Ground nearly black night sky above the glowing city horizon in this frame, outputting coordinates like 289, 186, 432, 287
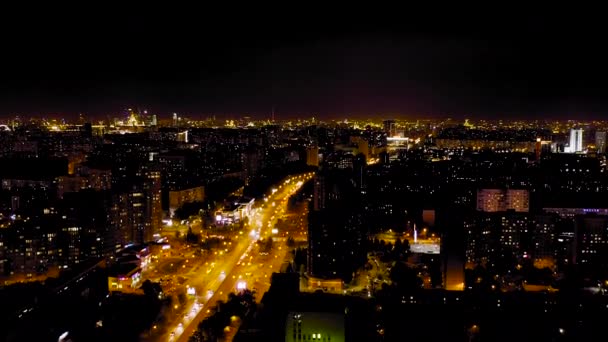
0, 4, 608, 118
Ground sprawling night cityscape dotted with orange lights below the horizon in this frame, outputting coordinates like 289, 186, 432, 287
0, 69, 608, 342
